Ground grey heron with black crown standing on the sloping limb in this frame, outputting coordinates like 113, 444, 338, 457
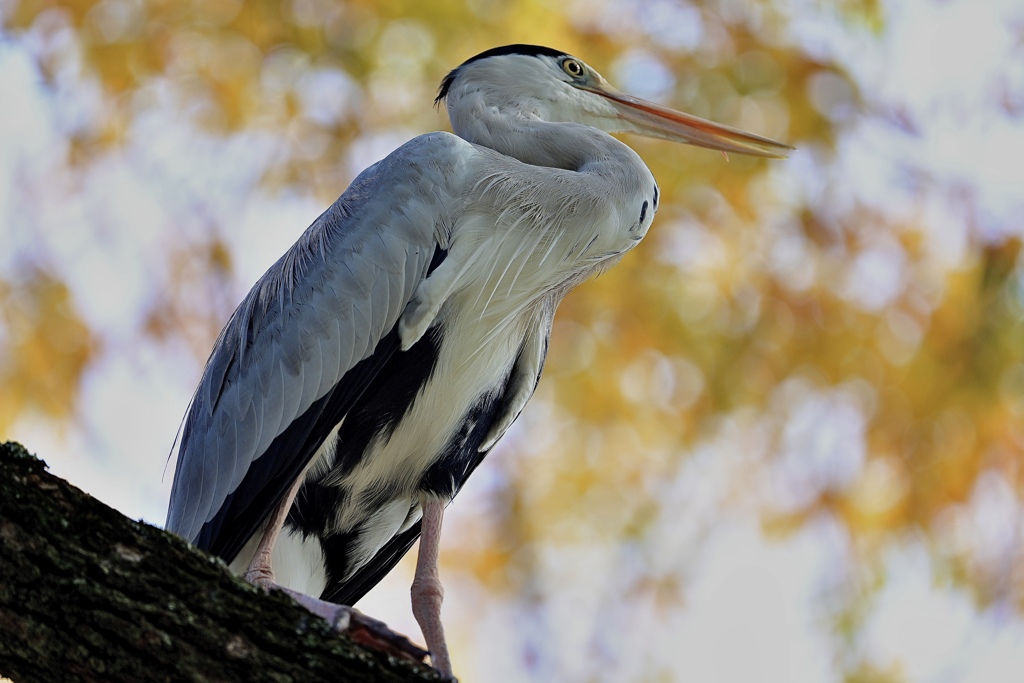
167, 45, 792, 676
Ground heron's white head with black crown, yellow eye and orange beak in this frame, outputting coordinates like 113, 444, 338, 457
435, 45, 793, 159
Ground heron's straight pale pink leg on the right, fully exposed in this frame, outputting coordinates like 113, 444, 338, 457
412, 499, 452, 678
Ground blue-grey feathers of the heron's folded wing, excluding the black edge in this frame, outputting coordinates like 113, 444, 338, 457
167, 133, 465, 541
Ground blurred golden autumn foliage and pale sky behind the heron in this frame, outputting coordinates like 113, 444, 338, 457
0, 0, 1024, 681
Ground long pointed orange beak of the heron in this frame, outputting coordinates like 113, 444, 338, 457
577, 80, 795, 159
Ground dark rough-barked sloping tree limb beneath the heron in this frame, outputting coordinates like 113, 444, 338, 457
0, 442, 438, 683
